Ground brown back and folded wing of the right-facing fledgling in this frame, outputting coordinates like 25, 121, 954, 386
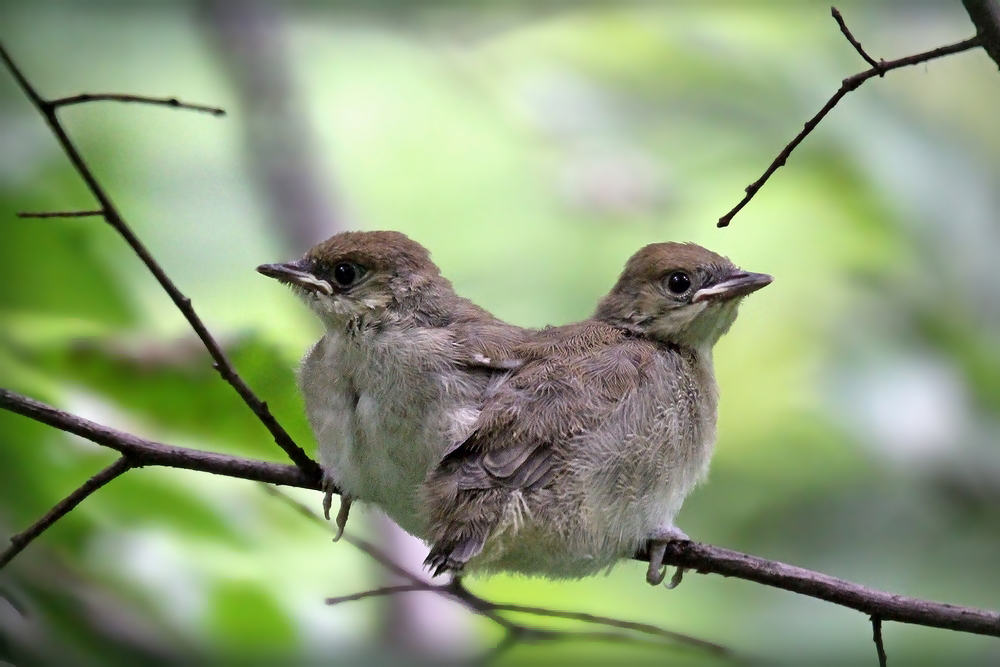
425, 322, 655, 572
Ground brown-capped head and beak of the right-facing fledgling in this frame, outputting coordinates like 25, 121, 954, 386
595, 243, 772, 349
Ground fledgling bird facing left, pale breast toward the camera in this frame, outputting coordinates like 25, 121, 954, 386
257, 231, 524, 537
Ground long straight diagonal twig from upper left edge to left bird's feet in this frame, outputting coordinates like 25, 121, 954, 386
0, 44, 322, 480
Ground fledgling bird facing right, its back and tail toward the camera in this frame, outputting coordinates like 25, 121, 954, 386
422, 243, 771, 584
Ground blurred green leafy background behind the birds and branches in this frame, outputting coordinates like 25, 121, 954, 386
0, 0, 1000, 665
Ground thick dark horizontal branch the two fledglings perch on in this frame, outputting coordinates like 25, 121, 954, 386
0, 389, 1000, 637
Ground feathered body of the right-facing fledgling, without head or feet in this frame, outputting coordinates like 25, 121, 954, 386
425, 322, 717, 577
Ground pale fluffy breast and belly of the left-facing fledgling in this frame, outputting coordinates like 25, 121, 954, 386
299, 328, 482, 537
